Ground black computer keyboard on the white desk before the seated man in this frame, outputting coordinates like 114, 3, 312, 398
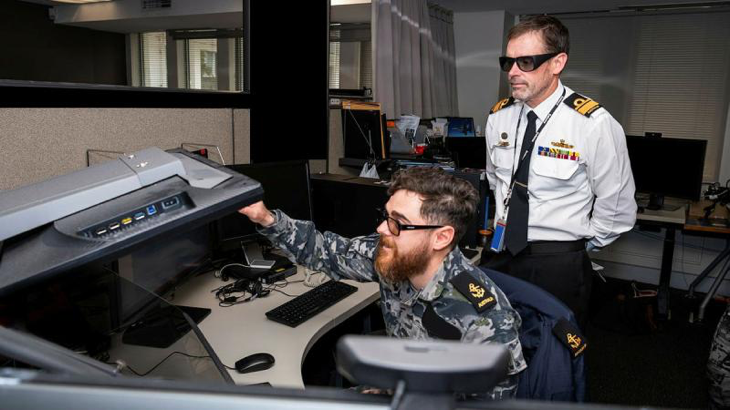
266, 280, 357, 327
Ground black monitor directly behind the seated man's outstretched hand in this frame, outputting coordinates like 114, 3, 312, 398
217, 160, 312, 249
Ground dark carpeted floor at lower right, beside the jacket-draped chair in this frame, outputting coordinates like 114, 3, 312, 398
585, 279, 725, 408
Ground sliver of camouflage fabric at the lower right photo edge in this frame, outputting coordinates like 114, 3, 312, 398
707, 305, 730, 409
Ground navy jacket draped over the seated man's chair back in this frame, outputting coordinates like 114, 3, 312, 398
482, 268, 587, 402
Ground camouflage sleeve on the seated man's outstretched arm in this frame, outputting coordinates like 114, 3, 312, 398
258, 210, 379, 282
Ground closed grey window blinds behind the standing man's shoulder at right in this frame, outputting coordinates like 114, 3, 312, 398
561, 11, 730, 182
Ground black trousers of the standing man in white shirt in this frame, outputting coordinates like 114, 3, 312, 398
481, 240, 593, 328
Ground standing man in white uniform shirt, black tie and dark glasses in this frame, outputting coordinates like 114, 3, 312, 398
483, 16, 636, 325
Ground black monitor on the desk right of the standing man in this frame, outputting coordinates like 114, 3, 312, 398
626, 135, 707, 209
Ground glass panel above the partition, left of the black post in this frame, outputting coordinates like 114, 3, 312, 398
0, 0, 248, 91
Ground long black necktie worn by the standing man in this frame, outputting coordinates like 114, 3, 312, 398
504, 111, 537, 255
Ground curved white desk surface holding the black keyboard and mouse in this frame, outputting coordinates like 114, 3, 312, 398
171, 268, 380, 389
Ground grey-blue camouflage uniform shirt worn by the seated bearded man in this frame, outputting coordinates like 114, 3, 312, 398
259, 210, 527, 399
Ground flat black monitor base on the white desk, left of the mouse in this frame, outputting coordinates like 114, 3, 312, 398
122, 305, 210, 349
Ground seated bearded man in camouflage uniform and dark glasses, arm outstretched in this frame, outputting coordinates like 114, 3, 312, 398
239, 168, 527, 399
